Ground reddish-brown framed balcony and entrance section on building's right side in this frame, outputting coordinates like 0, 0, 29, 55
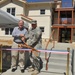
52, 0, 75, 43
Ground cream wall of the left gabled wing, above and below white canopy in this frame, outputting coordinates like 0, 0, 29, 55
0, 2, 23, 36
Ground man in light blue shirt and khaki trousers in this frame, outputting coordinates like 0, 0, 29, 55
11, 20, 27, 73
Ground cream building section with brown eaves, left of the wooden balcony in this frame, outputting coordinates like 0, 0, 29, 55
0, 0, 52, 38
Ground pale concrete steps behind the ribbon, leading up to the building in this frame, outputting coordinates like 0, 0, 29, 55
41, 43, 72, 75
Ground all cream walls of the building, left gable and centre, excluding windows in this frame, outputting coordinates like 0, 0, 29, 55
0, 0, 52, 39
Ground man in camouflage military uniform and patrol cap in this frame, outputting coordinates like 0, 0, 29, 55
25, 20, 42, 75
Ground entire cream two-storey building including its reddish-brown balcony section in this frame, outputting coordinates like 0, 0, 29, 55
0, 0, 75, 43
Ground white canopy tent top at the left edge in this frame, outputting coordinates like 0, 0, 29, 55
0, 9, 28, 27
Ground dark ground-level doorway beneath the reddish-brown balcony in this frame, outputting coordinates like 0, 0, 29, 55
59, 28, 71, 43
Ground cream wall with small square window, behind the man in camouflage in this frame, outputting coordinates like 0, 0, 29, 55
27, 4, 52, 38
